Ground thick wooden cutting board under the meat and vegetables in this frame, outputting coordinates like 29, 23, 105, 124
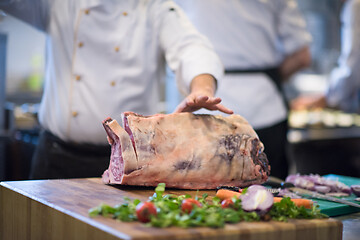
0, 178, 342, 240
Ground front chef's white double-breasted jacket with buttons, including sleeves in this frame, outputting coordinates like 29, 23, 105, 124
0, 0, 223, 144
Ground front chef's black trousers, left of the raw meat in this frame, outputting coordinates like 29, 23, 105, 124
30, 131, 111, 179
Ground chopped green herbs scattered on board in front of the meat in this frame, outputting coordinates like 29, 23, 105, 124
89, 183, 327, 228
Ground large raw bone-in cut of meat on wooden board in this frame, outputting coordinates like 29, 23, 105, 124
102, 112, 270, 189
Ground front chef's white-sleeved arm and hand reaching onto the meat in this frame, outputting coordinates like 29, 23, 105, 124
154, 1, 233, 114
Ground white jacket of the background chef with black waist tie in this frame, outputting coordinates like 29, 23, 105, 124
176, 0, 311, 128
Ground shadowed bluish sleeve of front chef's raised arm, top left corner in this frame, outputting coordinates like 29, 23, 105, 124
0, 0, 53, 31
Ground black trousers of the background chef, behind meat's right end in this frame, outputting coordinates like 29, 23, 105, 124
255, 121, 289, 179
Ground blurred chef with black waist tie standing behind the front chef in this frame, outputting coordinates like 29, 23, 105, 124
177, 0, 312, 178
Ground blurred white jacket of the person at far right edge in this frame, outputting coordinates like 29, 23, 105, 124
326, 0, 360, 112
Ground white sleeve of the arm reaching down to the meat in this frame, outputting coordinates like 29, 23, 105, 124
154, 1, 224, 95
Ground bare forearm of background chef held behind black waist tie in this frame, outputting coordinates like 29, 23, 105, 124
280, 46, 311, 81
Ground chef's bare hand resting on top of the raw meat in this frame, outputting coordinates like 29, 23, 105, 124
174, 74, 233, 114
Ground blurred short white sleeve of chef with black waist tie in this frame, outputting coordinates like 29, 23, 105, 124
275, 0, 312, 54
